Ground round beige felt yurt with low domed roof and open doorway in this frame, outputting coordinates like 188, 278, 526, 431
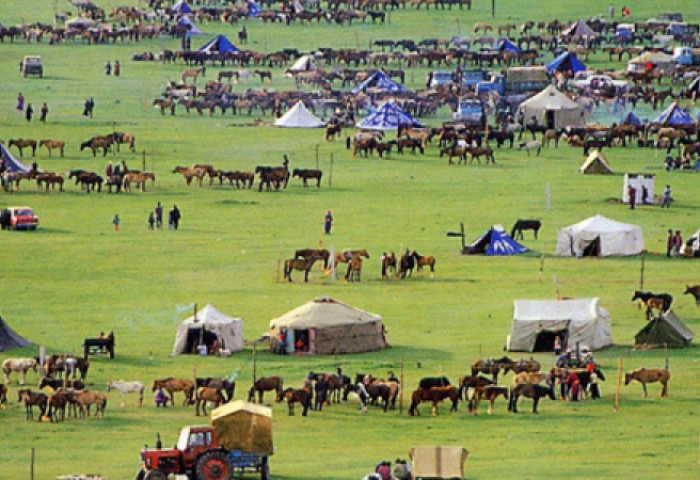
268, 297, 386, 355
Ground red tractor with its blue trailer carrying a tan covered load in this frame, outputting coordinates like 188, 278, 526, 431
136, 401, 272, 480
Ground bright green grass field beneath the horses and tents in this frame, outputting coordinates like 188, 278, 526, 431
0, 0, 700, 480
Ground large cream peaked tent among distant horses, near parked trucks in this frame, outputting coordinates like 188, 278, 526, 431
516, 85, 586, 129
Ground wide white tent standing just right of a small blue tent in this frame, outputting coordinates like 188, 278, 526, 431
556, 215, 644, 257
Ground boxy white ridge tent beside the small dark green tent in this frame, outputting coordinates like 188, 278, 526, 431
507, 298, 612, 352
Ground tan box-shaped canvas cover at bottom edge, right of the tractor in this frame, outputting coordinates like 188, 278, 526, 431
409, 445, 469, 480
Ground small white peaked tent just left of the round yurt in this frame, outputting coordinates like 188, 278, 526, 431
173, 303, 243, 353
